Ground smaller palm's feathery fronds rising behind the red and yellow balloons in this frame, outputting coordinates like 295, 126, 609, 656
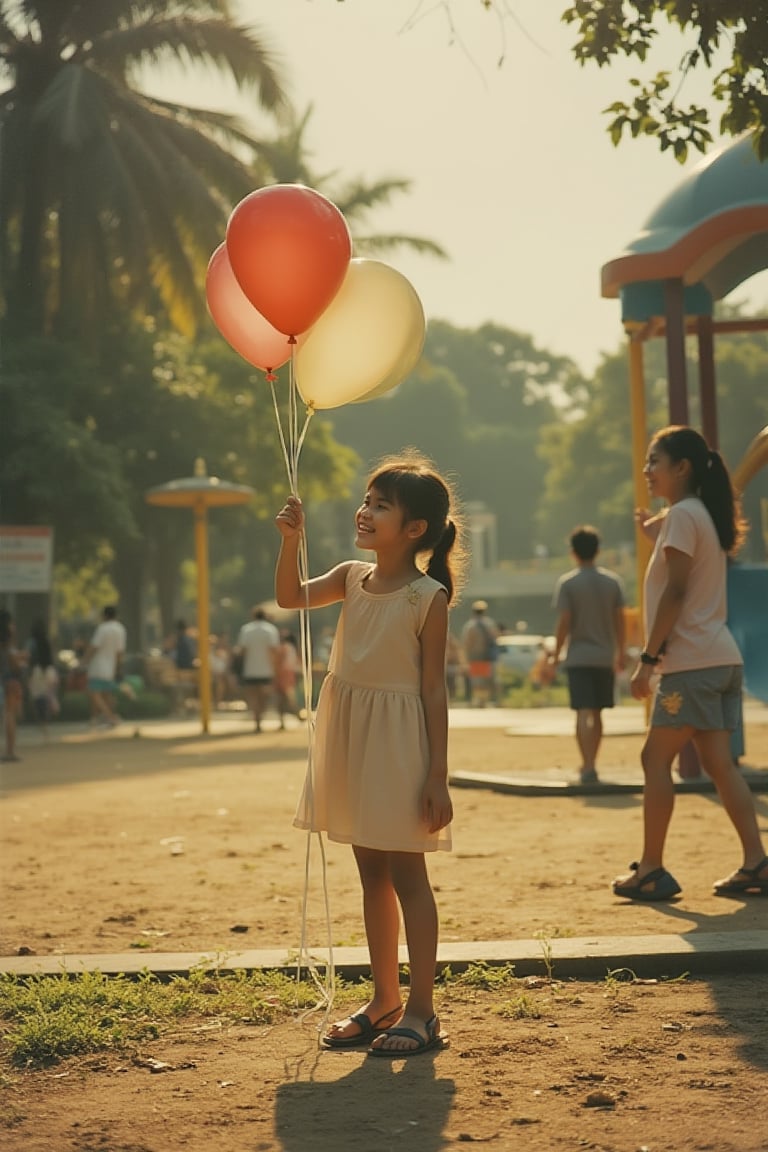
249, 105, 447, 259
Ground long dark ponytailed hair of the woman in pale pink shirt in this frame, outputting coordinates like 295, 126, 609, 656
653, 424, 747, 555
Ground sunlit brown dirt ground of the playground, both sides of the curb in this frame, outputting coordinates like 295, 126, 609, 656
0, 725, 768, 1152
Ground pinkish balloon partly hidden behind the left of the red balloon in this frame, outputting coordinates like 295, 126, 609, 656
205, 244, 291, 372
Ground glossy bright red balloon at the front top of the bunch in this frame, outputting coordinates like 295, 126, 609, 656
227, 184, 352, 336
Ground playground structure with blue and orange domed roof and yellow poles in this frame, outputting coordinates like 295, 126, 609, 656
601, 134, 768, 775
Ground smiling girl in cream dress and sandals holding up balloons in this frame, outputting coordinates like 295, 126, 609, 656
275, 454, 459, 1056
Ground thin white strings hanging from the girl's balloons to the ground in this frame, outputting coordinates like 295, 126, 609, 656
269, 352, 336, 1032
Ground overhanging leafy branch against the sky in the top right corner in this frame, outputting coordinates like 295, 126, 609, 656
562, 0, 768, 162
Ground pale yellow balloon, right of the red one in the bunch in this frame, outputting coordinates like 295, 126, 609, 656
296, 257, 426, 409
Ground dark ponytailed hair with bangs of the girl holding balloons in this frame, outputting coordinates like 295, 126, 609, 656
367, 449, 465, 601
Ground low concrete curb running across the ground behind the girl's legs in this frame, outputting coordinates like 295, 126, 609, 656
0, 931, 768, 980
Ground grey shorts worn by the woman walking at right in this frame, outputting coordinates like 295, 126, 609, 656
651, 664, 743, 732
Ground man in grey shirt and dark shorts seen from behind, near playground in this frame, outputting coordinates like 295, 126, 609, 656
550, 524, 625, 785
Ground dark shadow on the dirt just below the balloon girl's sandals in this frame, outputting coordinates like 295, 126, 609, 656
275, 1052, 456, 1152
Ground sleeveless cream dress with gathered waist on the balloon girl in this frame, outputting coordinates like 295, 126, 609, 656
294, 561, 450, 852
